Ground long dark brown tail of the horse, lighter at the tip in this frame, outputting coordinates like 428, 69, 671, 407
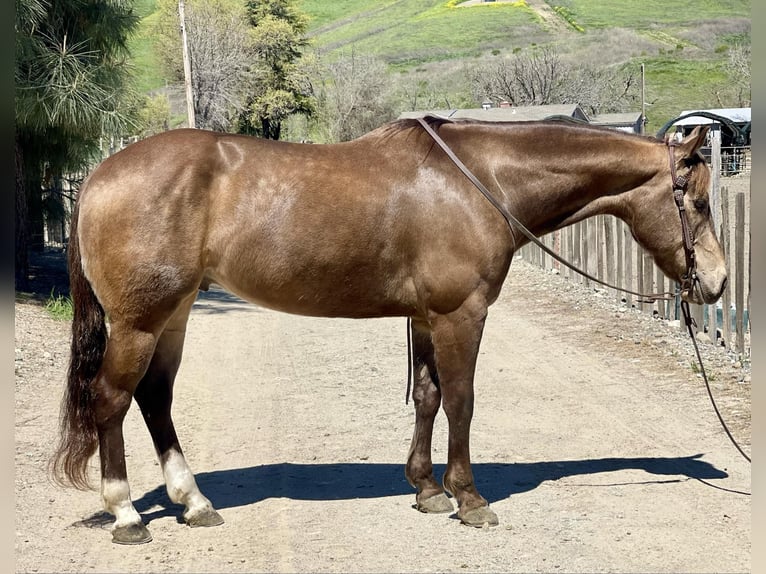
52, 196, 107, 490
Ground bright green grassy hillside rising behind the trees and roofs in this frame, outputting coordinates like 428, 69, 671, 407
132, 0, 751, 131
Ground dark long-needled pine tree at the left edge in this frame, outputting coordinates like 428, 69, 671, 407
14, 0, 138, 288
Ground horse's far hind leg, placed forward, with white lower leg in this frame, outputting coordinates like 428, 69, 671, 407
135, 293, 223, 526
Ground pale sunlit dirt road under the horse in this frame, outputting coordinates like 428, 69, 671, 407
15, 262, 751, 572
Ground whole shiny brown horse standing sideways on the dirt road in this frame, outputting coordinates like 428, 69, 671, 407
51, 116, 726, 544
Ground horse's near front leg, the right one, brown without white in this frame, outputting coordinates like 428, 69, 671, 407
432, 297, 498, 527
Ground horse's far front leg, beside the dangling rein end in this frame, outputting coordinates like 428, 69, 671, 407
405, 322, 453, 512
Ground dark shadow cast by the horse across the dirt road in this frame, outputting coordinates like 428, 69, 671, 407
114, 454, 729, 532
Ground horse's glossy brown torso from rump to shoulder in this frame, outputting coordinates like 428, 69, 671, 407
75, 128, 509, 324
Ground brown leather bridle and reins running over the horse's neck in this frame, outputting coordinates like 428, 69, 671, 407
416, 118, 751, 468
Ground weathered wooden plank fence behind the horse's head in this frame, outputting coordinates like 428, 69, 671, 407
521, 184, 750, 359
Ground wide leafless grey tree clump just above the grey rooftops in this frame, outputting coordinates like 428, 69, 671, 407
472, 47, 640, 114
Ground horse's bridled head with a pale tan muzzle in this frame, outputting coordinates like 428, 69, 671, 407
632, 127, 726, 304
